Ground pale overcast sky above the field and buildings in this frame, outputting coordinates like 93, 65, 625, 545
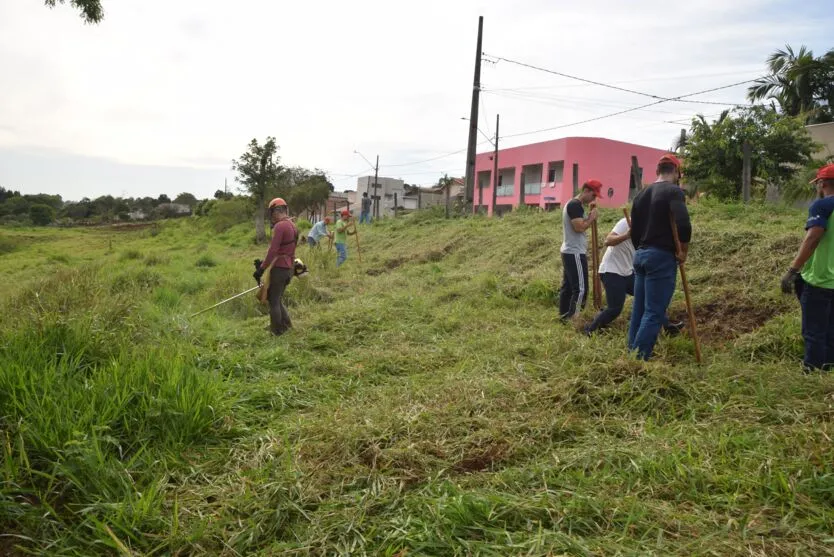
0, 0, 834, 199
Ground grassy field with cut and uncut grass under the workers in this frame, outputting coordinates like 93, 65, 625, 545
0, 201, 834, 556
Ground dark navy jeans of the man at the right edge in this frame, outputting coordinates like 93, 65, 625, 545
799, 282, 834, 370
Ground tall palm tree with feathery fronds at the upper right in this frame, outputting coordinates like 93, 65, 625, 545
747, 45, 834, 124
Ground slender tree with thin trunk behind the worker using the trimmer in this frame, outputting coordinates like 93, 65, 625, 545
232, 137, 284, 243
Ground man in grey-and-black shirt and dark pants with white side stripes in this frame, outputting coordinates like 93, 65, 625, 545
559, 180, 602, 322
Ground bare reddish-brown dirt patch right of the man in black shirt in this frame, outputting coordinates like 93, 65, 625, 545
669, 301, 785, 344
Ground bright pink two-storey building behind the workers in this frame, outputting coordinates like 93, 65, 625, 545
473, 137, 667, 215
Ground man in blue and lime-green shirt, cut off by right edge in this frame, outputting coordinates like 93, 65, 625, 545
781, 164, 834, 371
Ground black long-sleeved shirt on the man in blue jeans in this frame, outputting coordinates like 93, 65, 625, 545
631, 182, 692, 253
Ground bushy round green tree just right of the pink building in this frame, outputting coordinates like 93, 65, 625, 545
683, 106, 816, 199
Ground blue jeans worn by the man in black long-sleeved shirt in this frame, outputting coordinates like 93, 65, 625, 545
628, 247, 678, 360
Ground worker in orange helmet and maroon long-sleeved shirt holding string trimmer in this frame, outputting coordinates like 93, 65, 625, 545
255, 197, 298, 336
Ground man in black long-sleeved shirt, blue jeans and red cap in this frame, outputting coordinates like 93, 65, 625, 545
628, 154, 692, 360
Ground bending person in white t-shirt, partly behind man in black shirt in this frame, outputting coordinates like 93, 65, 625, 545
585, 219, 683, 335
